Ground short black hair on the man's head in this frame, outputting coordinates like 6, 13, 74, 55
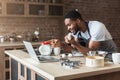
64, 10, 83, 20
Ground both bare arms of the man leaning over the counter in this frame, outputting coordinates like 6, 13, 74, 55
51, 39, 100, 55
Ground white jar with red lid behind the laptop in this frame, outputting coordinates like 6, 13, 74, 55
39, 41, 52, 56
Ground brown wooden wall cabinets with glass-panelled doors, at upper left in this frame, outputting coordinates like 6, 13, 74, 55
0, 0, 64, 17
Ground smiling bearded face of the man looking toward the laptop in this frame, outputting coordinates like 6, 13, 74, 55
64, 18, 80, 34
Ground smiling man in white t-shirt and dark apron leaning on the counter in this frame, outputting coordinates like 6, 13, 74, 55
52, 10, 117, 55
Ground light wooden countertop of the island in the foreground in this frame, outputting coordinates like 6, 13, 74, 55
5, 50, 120, 80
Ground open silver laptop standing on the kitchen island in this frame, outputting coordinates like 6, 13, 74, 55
23, 41, 59, 62
